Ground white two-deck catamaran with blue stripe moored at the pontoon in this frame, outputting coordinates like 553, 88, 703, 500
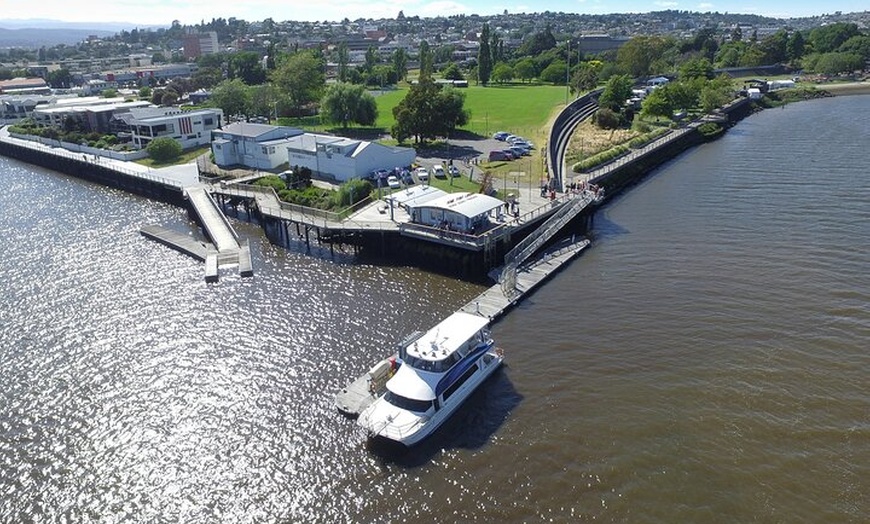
357, 312, 503, 446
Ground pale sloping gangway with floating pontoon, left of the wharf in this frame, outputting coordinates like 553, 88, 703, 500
139, 186, 254, 282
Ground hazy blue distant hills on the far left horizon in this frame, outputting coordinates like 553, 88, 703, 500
0, 19, 166, 49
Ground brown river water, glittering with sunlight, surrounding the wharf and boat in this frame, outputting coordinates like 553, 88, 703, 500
0, 96, 870, 523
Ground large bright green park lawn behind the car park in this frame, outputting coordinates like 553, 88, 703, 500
375, 84, 565, 137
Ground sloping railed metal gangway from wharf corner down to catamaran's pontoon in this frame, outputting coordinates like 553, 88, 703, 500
499, 190, 598, 297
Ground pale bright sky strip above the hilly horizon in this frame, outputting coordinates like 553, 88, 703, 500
0, 0, 868, 26
